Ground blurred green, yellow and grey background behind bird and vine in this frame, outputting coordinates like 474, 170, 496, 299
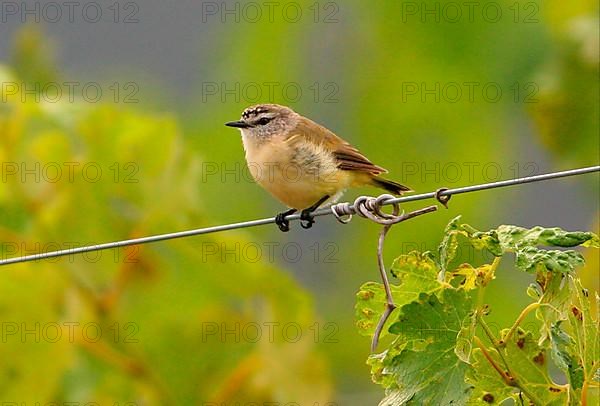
0, 0, 600, 405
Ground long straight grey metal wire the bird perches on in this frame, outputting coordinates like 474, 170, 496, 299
0, 165, 600, 266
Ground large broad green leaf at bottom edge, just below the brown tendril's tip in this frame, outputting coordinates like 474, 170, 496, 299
381, 289, 471, 405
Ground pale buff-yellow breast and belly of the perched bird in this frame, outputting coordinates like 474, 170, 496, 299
243, 137, 351, 210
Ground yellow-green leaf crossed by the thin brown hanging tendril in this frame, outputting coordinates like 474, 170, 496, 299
355, 251, 442, 337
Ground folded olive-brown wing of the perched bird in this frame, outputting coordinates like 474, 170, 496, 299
286, 118, 387, 175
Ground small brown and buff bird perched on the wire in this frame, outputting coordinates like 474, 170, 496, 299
225, 104, 411, 232
